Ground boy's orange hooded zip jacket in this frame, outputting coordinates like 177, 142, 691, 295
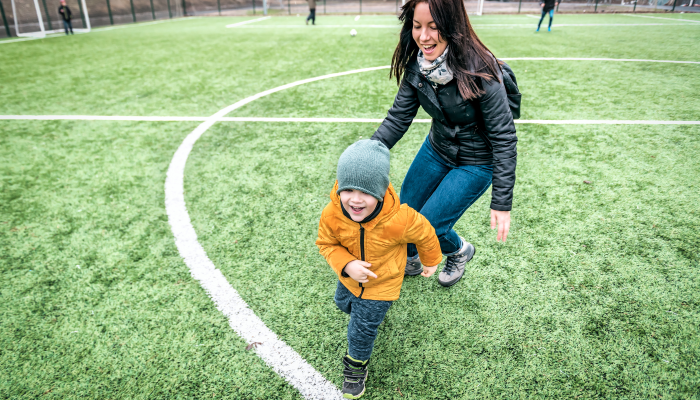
316, 181, 442, 301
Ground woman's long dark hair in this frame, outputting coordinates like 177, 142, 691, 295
389, 0, 498, 100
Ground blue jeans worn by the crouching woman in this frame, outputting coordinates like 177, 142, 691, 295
400, 138, 493, 257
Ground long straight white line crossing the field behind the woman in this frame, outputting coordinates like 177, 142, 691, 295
0, 115, 700, 125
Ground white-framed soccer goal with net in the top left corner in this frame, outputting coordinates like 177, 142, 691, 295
11, 0, 90, 37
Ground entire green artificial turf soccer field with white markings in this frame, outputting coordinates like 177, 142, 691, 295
0, 14, 700, 399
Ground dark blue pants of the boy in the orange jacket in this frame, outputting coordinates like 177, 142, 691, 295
335, 282, 393, 361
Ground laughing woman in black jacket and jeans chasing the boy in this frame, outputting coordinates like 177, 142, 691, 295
372, 0, 518, 287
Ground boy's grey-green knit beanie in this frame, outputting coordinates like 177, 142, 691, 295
337, 139, 389, 201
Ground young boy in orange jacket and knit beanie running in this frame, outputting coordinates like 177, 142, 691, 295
316, 139, 442, 399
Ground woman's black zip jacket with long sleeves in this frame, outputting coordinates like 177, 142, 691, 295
372, 60, 518, 211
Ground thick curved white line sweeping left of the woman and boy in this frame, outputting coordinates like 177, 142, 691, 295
165, 67, 396, 400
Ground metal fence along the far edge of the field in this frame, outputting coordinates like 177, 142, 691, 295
0, 0, 700, 37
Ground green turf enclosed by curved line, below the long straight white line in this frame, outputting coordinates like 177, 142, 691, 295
186, 123, 700, 399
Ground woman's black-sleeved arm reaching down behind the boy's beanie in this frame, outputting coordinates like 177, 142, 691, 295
371, 79, 420, 149
